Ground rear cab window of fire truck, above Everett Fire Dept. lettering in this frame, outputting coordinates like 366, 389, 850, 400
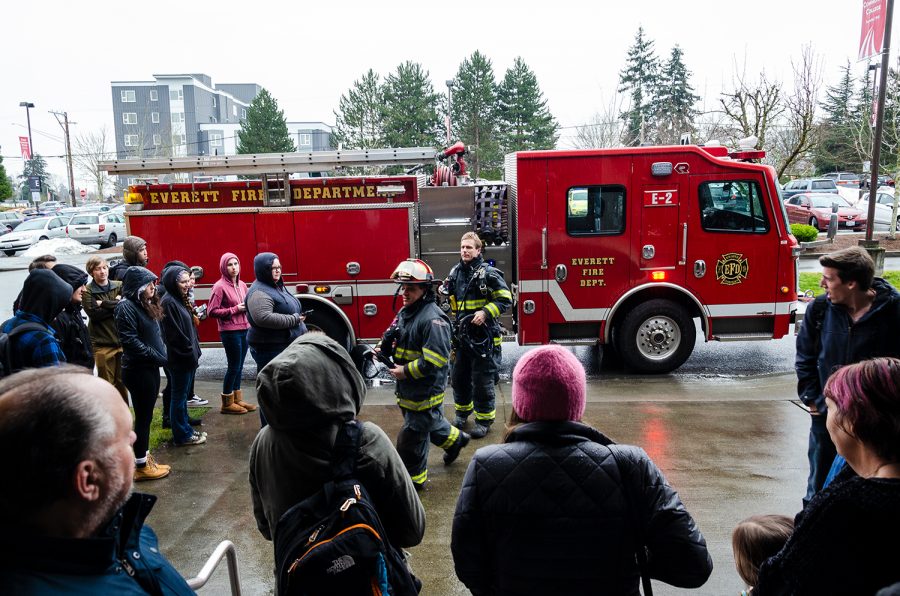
566, 186, 625, 236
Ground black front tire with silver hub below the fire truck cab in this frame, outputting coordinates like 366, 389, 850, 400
616, 299, 697, 374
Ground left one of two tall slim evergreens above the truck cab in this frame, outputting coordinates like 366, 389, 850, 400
619, 27, 659, 146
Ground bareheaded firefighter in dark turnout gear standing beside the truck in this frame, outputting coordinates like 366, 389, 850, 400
442, 232, 512, 439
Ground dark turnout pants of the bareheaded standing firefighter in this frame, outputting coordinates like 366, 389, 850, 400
450, 346, 500, 424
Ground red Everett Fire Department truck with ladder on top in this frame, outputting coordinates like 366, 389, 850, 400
104, 144, 799, 373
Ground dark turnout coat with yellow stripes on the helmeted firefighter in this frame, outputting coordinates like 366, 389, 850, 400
394, 294, 450, 411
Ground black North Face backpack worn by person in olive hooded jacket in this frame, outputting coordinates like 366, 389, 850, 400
274, 420, 421, 596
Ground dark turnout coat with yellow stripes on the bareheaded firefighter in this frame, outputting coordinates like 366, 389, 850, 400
446, 256, 512, 344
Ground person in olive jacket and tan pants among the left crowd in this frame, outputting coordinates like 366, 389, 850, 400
81, 256, 128, 404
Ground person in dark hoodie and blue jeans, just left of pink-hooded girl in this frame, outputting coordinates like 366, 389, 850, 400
161, 265, 206, 446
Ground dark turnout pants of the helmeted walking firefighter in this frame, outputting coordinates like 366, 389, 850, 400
397, 405, 460, 485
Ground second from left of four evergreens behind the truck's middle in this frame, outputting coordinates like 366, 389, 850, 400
382, 61, 441, 147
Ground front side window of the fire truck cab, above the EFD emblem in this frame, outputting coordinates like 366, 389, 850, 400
699, 180, 769, 234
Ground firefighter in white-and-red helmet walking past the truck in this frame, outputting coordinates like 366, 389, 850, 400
378, 259, 469, 490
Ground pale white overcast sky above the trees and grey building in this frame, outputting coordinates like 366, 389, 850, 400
0, 0, 900, 187
